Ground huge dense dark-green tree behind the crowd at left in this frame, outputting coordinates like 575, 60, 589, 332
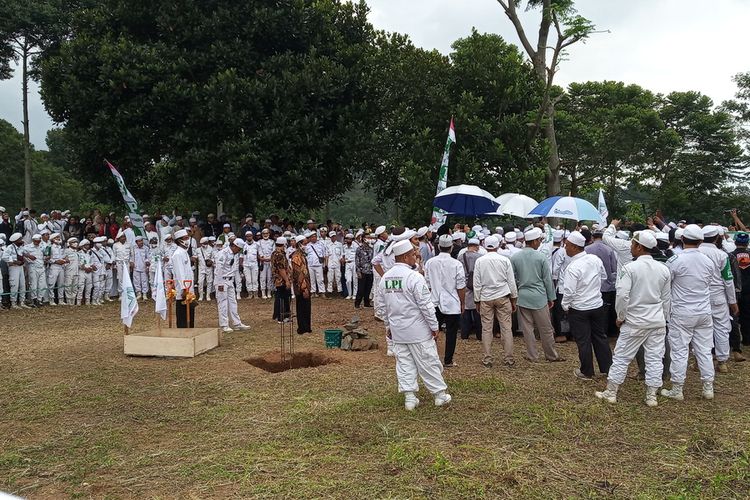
37, 0, 373, 213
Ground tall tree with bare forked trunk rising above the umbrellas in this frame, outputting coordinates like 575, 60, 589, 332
497, 0, 594, 196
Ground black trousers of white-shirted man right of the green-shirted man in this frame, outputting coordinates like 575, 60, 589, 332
568, 306, 612, 377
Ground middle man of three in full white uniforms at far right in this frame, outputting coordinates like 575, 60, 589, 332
660, 224, 716, 401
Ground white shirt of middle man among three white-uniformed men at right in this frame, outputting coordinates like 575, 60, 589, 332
667, 248, 714, 316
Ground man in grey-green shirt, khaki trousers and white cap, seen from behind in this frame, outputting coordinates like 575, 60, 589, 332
510, 227, 564, 362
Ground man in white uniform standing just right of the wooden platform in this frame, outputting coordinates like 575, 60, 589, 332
215, 238, 250, 333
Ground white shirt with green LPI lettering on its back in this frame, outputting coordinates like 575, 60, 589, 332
377, 263, 439, 344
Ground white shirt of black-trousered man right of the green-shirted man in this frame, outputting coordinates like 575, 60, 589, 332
561, 252, 607, 311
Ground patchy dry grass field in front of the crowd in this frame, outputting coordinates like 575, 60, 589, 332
0, 299, 750, 498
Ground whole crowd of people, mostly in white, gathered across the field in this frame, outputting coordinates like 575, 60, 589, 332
0, 207, 750, 410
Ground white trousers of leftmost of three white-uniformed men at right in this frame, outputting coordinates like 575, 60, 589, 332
607, 324, 667, 387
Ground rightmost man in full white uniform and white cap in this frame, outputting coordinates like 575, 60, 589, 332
698, 226, 740, 373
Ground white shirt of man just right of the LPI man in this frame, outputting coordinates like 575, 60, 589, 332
424, 253, 466, 314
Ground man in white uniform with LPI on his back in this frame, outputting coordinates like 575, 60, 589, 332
378, 239, 452, 410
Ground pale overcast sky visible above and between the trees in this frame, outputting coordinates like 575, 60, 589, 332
0, 0, 750, 149
